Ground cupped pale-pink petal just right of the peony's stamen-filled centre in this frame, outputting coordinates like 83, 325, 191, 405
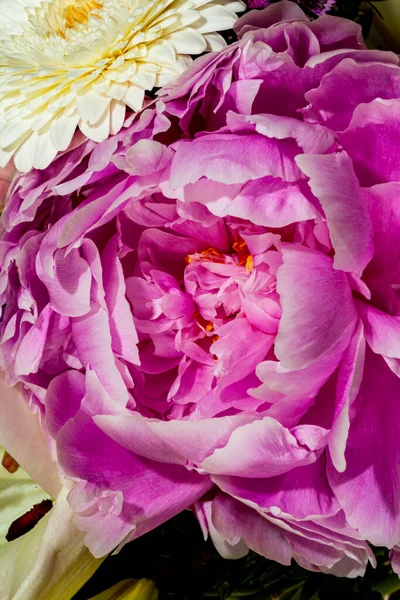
275, 246, 357, 369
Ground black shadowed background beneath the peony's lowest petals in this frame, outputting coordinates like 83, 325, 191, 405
73, 511, 400, 600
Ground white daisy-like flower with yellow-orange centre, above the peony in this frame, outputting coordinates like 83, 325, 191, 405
0, 0, 244, 172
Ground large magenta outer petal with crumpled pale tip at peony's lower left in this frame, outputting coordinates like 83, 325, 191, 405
56, 371, 211, 556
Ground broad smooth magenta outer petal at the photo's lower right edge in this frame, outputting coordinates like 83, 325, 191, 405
328, 352, 400, 548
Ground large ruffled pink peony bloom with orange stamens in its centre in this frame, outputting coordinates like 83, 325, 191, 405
0, 2, 400, 577
